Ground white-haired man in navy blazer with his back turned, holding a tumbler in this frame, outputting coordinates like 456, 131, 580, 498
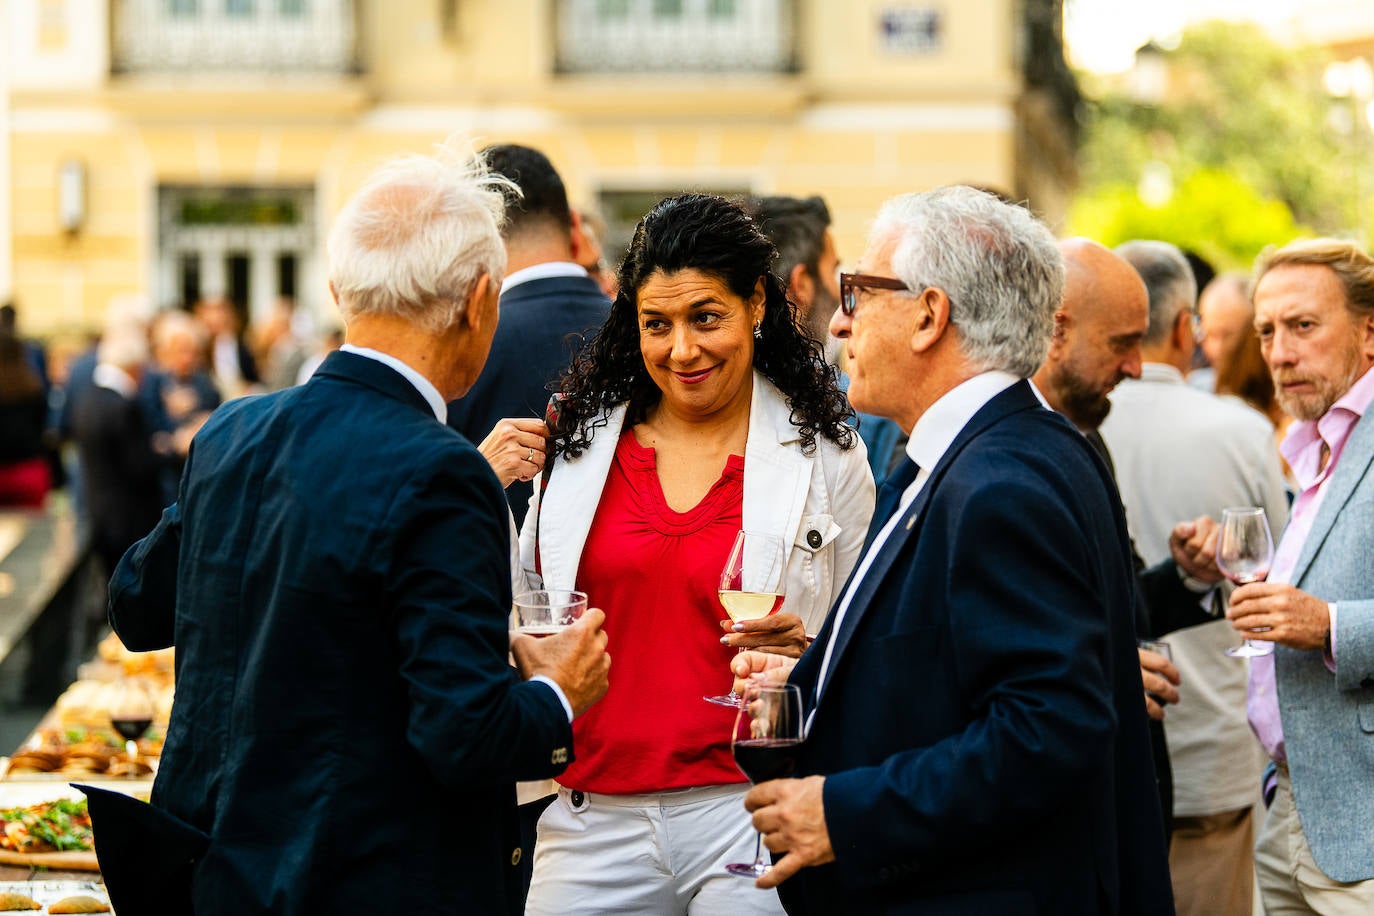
92, 146, 609, 916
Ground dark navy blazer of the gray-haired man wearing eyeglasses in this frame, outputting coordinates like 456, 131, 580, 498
780, 383, 1173, 916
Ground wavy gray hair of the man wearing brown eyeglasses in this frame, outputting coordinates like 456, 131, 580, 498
871, 185, 1063, 379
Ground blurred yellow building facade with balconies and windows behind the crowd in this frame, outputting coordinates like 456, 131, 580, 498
0, 0, 1076, 334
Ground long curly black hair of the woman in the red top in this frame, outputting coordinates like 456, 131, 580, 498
554, 194, 855, 457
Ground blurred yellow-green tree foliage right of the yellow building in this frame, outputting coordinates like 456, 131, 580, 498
1069, 22, 1357, 268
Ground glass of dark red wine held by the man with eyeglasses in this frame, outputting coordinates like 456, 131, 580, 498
725, 684, 802, 878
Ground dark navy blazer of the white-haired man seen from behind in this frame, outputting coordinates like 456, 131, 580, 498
107, 353, 572, 916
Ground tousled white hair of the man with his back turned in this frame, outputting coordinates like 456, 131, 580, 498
328, 144, 513, 334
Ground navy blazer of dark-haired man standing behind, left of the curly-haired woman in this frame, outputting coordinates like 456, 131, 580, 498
448, 276, 610, 530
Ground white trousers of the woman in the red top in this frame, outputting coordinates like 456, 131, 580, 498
525, 784, 783, 916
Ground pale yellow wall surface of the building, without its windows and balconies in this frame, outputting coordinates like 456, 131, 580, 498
2, 0, 1033, 335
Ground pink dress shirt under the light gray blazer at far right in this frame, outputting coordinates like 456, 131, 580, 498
1245, 369, 1374, 764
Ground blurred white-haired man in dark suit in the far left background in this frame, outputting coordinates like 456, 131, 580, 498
71, 324, 165, 573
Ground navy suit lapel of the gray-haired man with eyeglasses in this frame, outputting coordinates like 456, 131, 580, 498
818, 382, 1040, 703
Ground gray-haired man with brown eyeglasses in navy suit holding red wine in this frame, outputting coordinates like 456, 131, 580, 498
732, 187, 1172, 916
